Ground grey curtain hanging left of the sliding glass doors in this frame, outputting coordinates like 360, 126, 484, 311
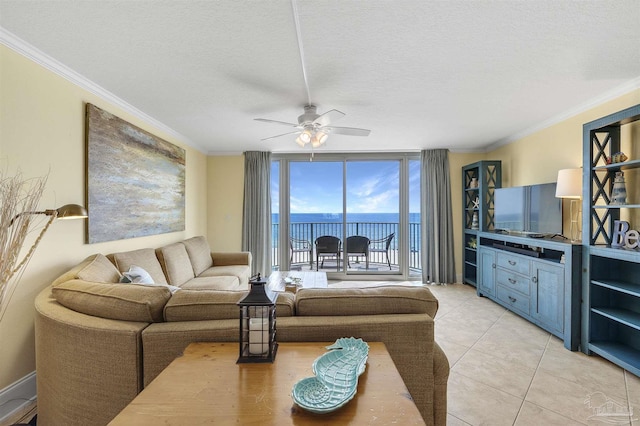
242, 151, 271, 278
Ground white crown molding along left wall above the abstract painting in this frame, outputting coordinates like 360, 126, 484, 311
0, 26, 205, 154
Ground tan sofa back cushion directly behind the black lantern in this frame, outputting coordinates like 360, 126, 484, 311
164, 290, 295, 322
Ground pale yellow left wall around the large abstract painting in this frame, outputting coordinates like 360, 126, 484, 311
0, 45, 207, 390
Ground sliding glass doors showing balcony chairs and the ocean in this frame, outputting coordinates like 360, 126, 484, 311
272, 154, 419, 279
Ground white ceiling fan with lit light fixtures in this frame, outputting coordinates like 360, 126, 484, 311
254, 104, 371, 148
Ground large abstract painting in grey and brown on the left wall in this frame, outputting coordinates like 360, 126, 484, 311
86, 104, 186, 244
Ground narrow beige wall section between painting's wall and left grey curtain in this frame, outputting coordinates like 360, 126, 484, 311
207, 155, 244, 251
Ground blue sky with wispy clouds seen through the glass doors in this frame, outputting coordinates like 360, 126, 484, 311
271, 160, 420, 213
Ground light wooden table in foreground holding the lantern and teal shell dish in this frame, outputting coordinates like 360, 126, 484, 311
109, 342, 425, 426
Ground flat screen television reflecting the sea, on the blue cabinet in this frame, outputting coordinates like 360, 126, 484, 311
494, 182, 562, 236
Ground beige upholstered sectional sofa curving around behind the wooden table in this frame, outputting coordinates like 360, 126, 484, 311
35, 237, 449, 426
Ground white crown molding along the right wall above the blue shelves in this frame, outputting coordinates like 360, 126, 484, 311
485, 77, 640, 152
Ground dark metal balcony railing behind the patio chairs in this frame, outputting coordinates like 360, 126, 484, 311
271, 222, 422, 272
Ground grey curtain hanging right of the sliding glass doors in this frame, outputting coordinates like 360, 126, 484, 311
420, 149, 456, 284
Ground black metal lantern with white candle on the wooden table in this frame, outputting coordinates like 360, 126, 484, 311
238, 274, 278, 363
